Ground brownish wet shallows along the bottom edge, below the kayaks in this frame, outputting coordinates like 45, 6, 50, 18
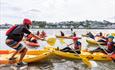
0, 59, 115, 70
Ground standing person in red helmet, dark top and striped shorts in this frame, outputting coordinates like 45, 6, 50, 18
6, 18, 40, 66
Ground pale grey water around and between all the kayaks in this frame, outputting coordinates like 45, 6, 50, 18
0, 29, 115, 70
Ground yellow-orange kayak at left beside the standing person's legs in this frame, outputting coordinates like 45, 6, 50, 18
0, 49, 52, 64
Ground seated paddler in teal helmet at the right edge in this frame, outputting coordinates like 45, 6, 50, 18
91, 36, 115, 54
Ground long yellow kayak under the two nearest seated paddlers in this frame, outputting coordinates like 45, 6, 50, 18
54, 50, 115, 61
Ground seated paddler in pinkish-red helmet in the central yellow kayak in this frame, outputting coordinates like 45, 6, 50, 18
60, 37, 81, 54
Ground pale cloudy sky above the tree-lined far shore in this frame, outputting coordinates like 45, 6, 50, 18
0, 0, 115, 24
